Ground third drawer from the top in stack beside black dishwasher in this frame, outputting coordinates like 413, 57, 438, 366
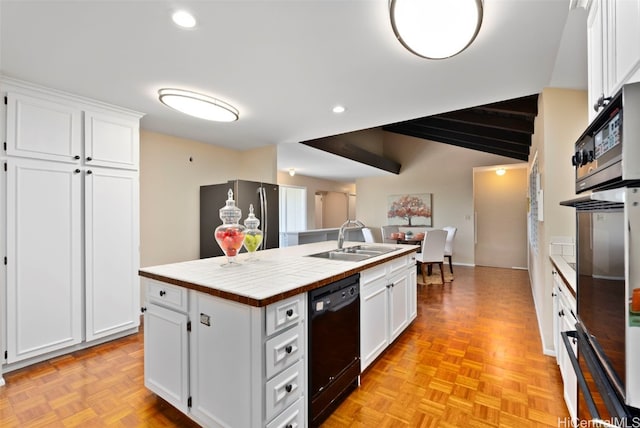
265, 360, 304, 420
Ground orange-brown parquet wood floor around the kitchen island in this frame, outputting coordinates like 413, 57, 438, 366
0, 267, 568, 428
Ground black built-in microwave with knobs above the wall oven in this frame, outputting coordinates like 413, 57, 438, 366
571, 82, 640, 193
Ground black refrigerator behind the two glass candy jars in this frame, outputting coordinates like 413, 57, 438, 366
200, 180, 280, 259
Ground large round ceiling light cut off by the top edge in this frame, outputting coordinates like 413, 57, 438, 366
389, 0, 482, 59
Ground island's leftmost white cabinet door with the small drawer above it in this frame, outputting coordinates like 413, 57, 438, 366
144, 280, 190, 413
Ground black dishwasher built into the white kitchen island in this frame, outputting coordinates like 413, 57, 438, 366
308, 274, 360, 427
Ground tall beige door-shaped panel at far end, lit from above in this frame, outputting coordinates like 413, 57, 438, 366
473, 165, 527, 268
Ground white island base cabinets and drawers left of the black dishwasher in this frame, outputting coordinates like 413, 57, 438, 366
143, 278, 306, 427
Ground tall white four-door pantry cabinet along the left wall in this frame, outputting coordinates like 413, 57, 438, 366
0, 77, 141, 369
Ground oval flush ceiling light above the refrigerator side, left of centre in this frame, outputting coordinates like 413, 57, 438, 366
158, 88, 240, 122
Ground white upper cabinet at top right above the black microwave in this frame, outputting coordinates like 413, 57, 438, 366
587, 0, 640, 121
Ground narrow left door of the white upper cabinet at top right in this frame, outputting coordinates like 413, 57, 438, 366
587, 0, 607, 121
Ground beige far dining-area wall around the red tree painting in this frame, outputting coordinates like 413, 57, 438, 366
356, 132, 518, 265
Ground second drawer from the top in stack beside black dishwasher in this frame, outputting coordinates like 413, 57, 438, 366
265, 324, 305, 379
